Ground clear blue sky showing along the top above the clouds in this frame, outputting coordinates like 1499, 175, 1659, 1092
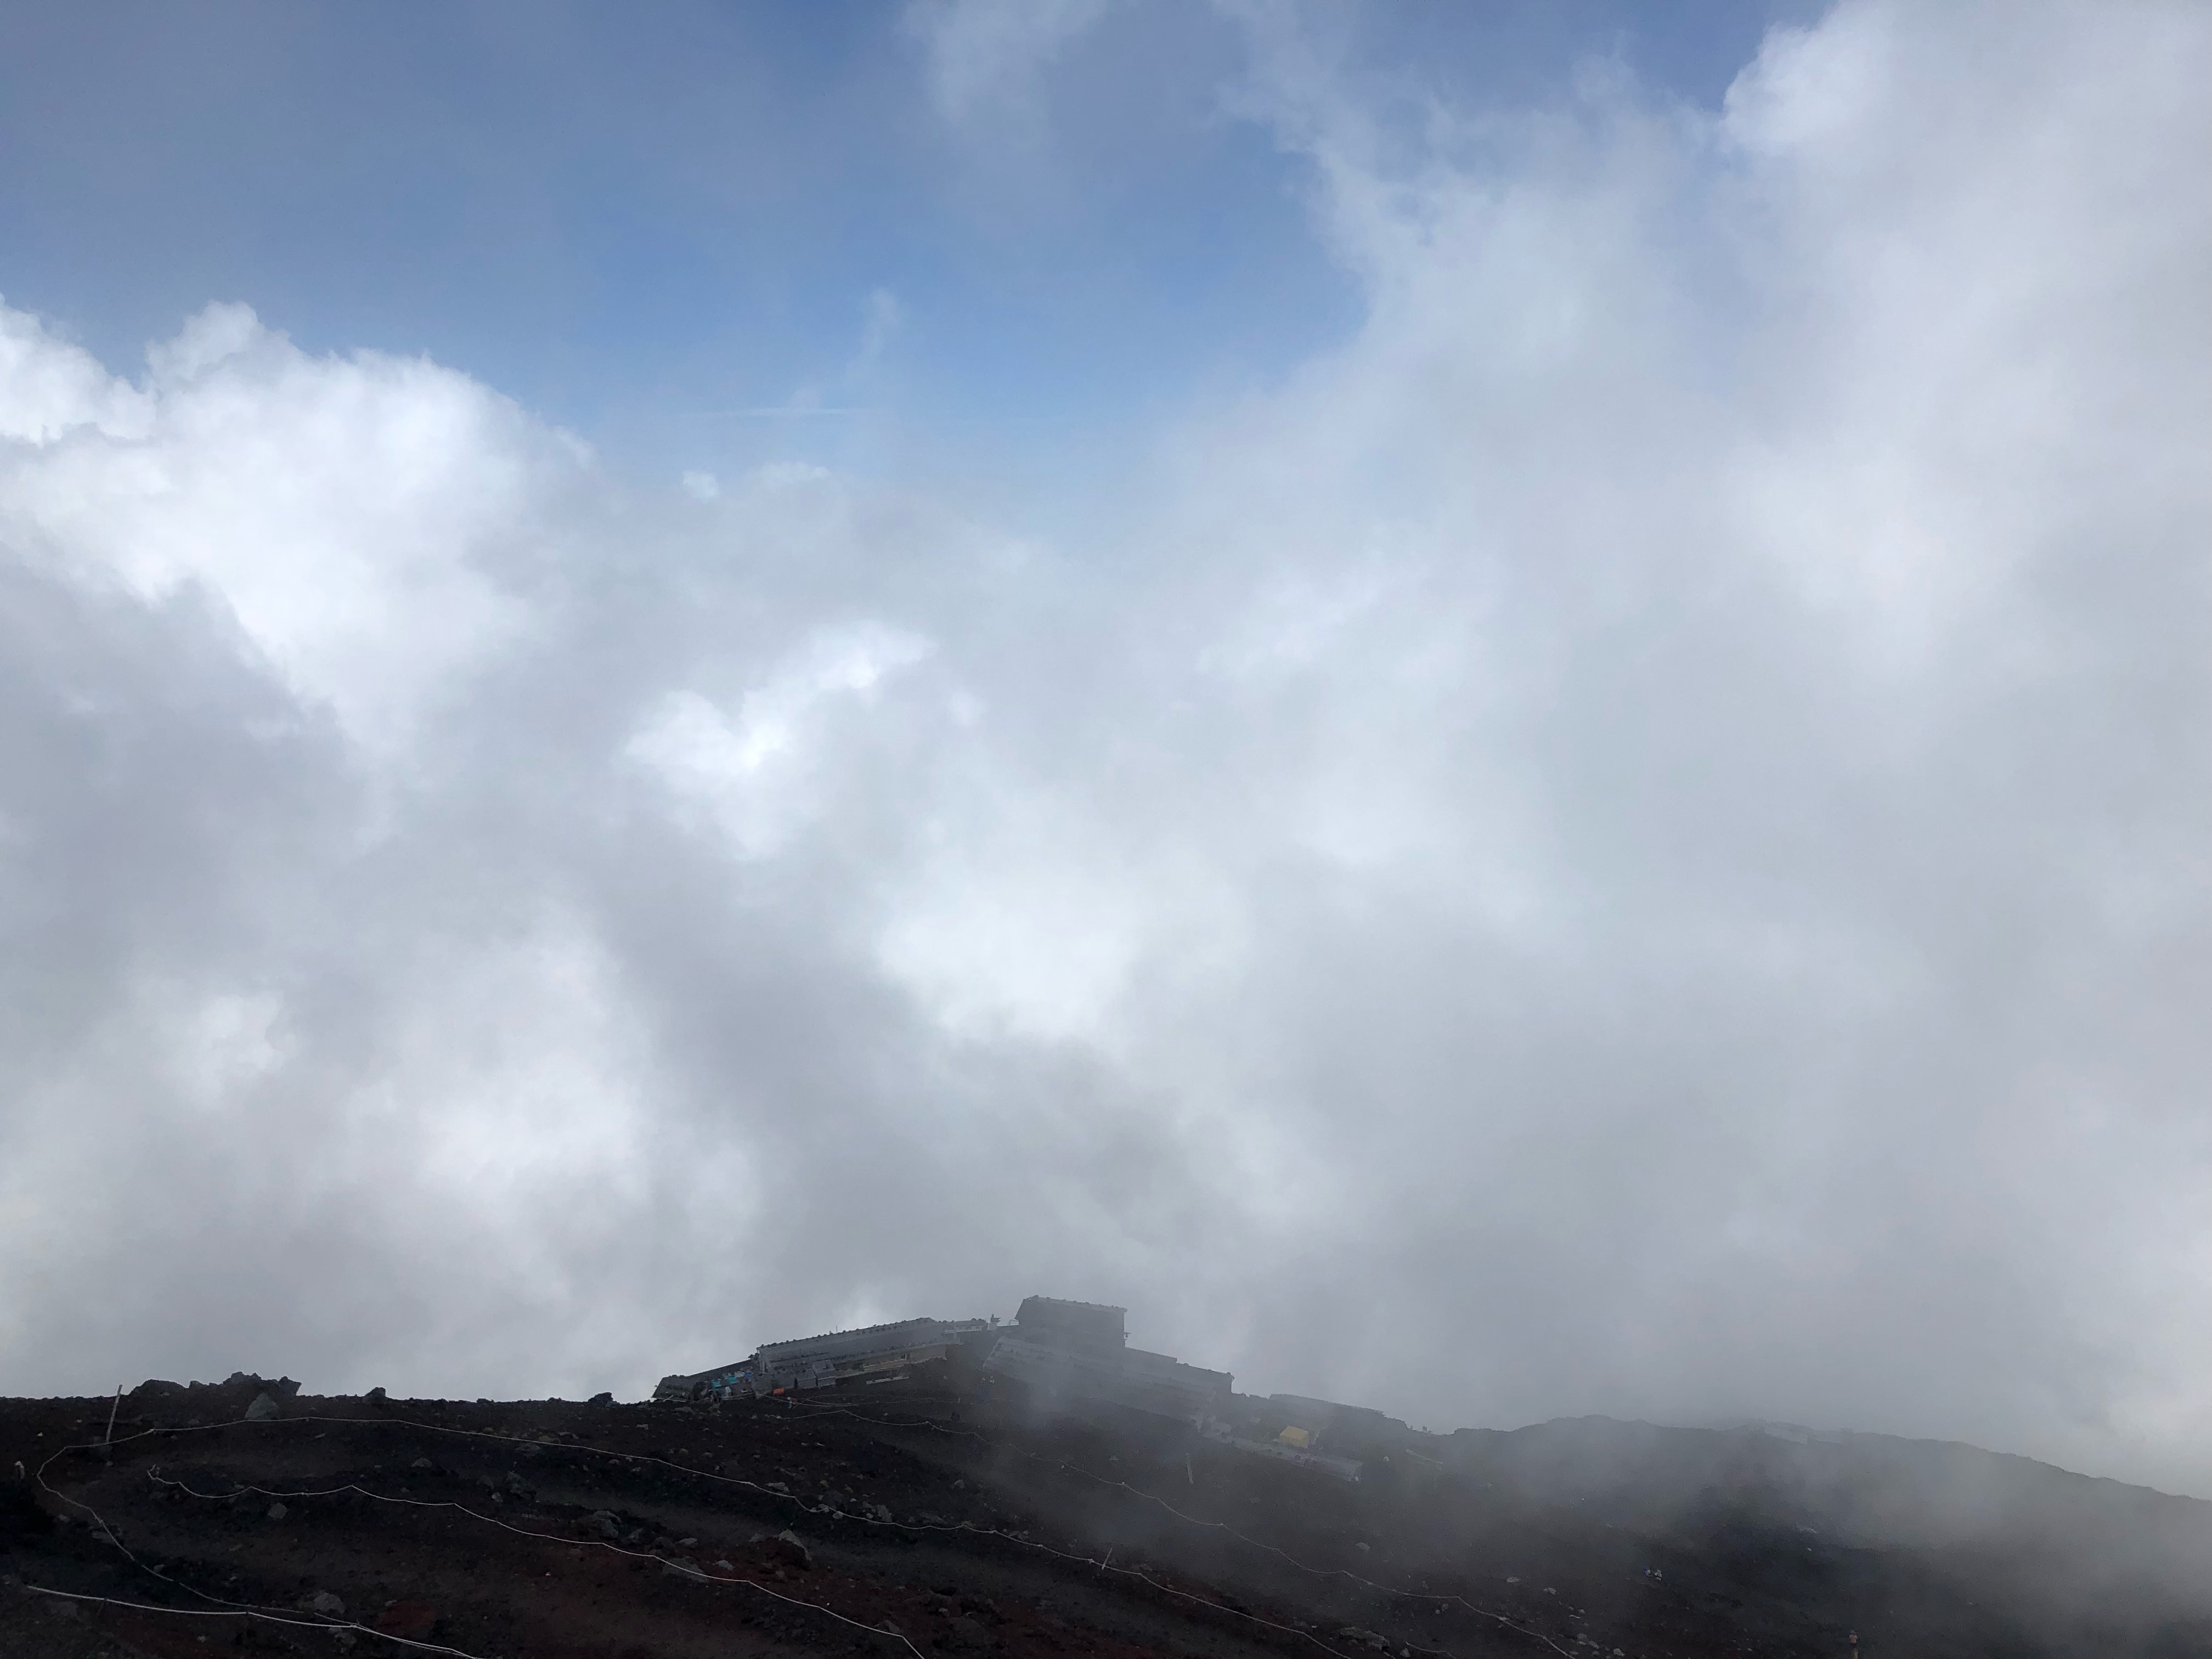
0, 2, 1803, 479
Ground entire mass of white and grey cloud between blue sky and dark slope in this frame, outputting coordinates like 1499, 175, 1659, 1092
0, 4, 2212, 1496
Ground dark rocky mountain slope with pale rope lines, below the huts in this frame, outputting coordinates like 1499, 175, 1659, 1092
0, 1367, 2212, 1659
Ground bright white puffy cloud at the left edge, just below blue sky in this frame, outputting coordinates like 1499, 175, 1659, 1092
0, 305, 584, 741
